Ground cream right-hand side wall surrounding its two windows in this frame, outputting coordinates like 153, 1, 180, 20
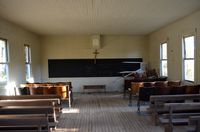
149, 11, 200, 83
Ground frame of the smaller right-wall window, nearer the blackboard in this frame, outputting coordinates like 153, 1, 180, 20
160, 41, 168, 77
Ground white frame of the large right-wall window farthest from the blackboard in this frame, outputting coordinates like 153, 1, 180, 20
182, 34, 196, 83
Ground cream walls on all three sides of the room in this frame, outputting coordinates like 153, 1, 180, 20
0, 8, 200, 94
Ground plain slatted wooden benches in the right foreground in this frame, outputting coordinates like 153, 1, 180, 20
149, 94, 200, 132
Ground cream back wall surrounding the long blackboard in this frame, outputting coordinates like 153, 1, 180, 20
41, 35, 148, 91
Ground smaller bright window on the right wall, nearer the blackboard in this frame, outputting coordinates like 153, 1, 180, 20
160, 43, 168, 76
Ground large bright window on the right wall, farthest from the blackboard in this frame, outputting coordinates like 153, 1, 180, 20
183, 36, 195, 81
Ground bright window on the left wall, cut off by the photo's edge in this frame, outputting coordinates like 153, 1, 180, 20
0, 39, 8, 83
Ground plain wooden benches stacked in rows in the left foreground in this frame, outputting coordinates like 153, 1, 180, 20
0, 95, 62, 132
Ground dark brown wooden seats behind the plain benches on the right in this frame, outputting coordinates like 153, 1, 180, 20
129, 81, 200, 111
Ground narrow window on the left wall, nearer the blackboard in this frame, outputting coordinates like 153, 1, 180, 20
24, 45, 31, 81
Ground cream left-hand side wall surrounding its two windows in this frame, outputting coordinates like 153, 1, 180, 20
0, 18, 41, 94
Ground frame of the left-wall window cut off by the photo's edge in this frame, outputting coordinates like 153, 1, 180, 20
0, 38, 9, 84
